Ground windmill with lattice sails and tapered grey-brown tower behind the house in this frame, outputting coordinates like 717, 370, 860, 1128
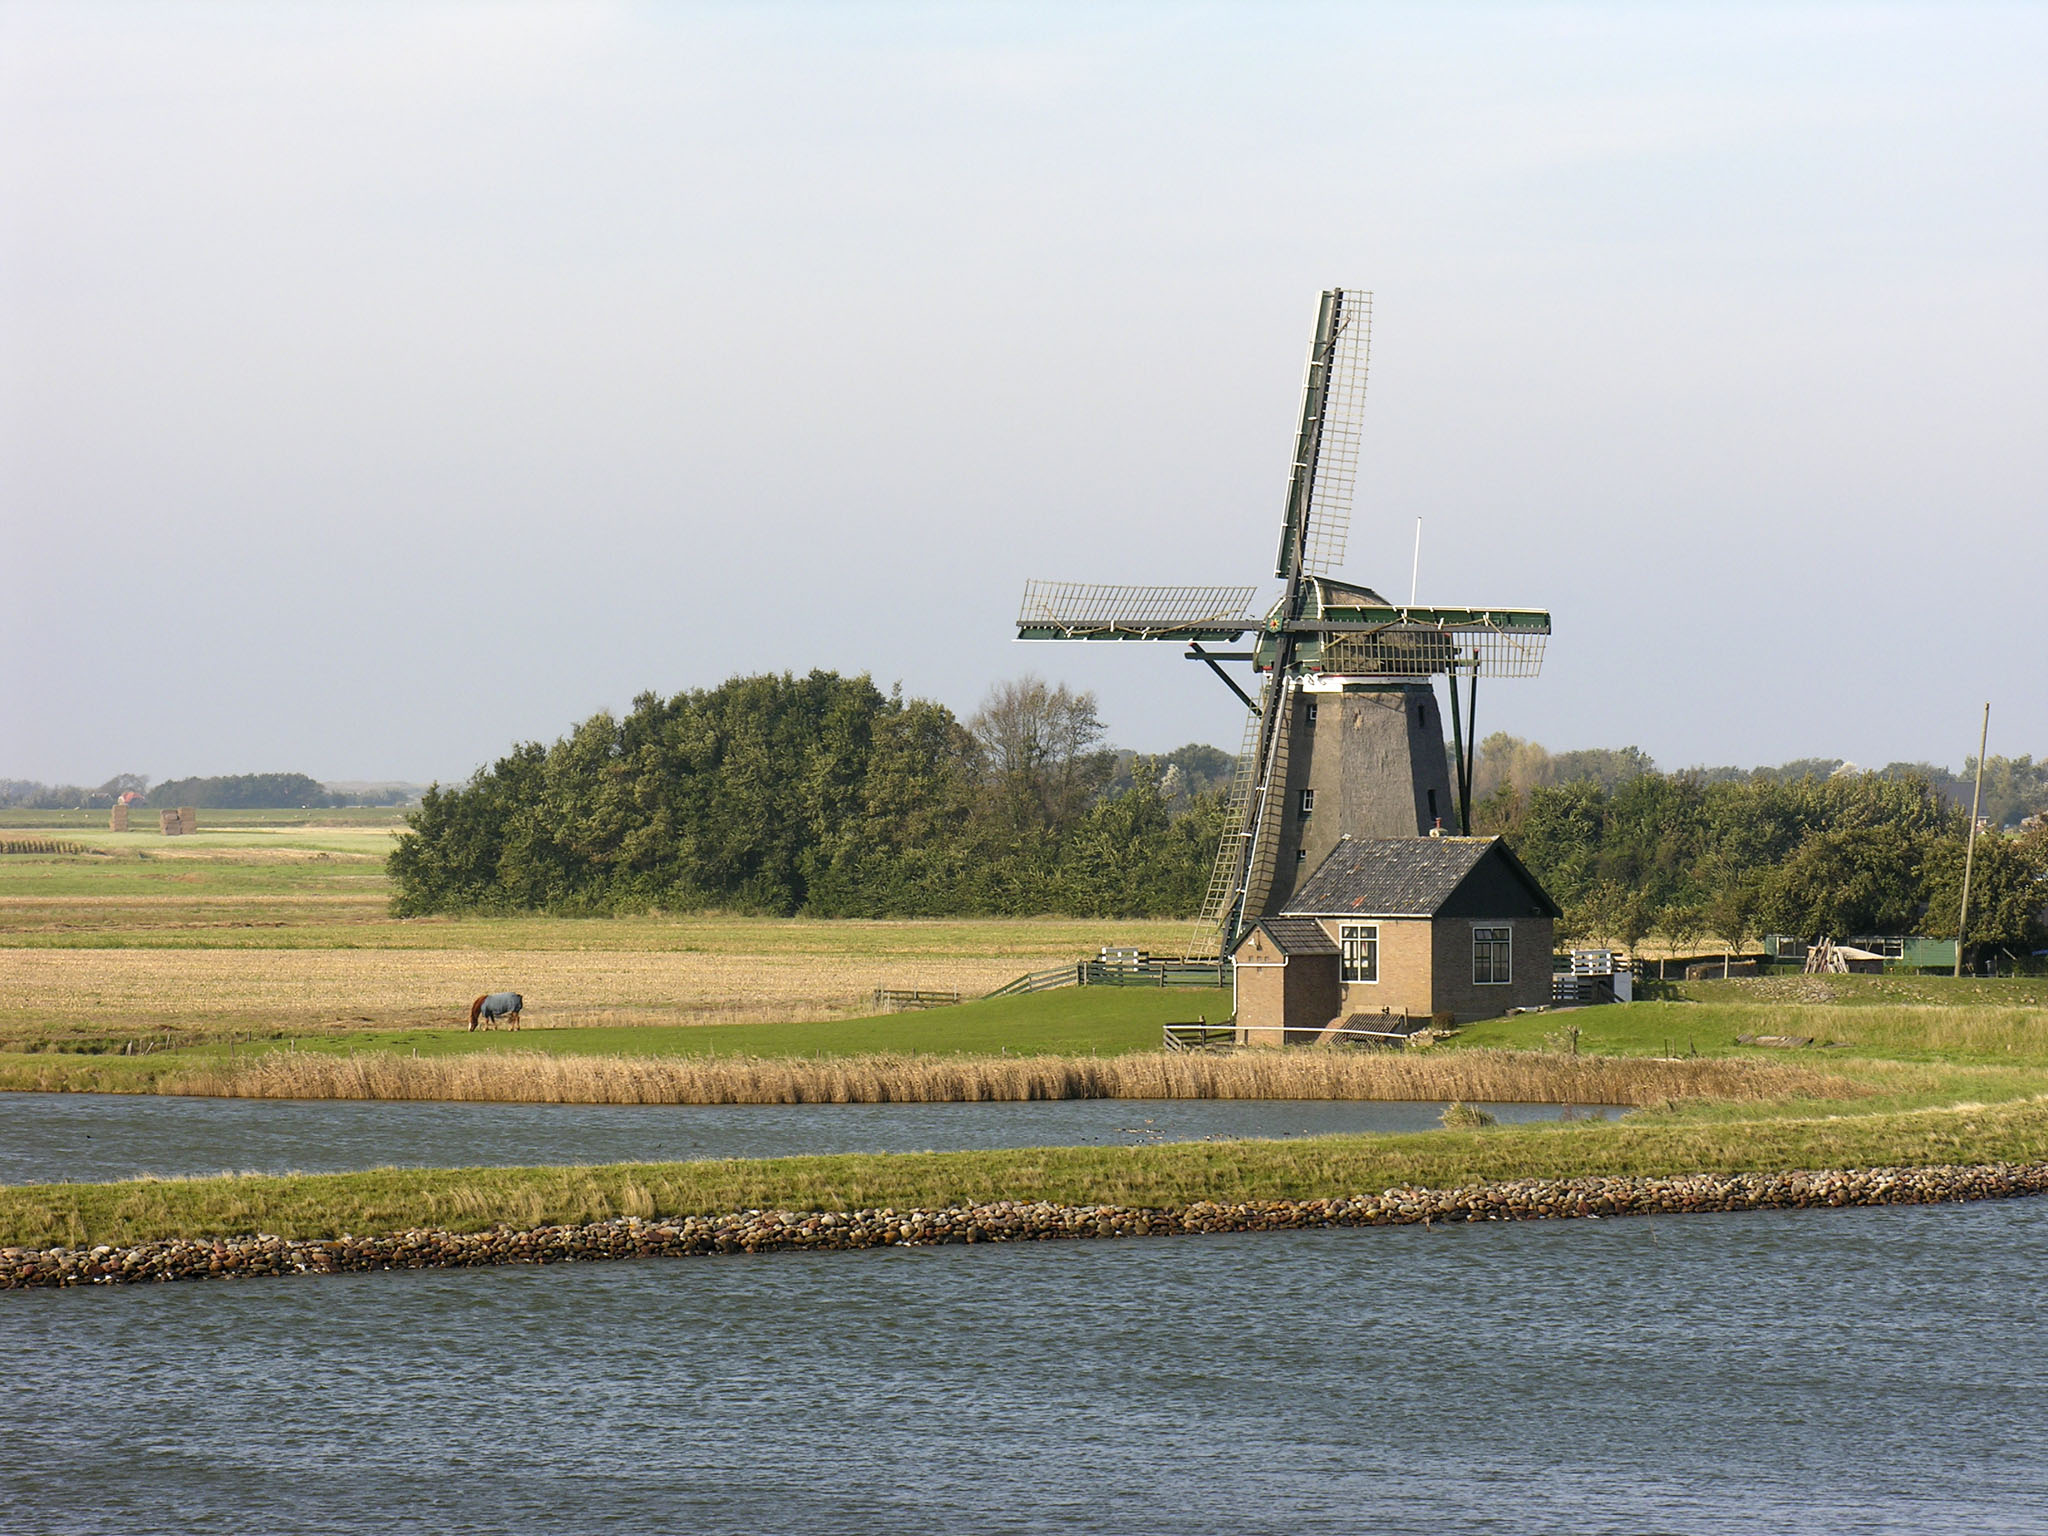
1018, 289, 1550, 956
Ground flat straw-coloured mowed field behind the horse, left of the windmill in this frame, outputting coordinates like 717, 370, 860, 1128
0, 811, 1188, 1051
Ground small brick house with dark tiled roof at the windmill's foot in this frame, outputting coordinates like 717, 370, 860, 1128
1231, 838, 1559, 1044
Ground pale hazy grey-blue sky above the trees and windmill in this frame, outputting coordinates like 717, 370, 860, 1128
0, 0, 2048, 782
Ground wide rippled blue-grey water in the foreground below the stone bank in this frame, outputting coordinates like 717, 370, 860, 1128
0, 1200, 2048, 1536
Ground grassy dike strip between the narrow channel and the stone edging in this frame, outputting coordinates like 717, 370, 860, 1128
0, 1098, 2048, 1247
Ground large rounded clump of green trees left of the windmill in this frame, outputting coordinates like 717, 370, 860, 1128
389, 672, 1227, 918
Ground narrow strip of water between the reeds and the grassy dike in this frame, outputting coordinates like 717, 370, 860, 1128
0, 1094, 1618, 1184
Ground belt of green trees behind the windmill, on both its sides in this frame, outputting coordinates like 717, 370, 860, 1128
391, 672, 2048, 954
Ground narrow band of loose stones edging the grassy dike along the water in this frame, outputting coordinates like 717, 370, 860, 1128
0, 1163, 2048, 1290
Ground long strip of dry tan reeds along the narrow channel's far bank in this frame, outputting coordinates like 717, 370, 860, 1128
158, 1051, 1868, 1106
